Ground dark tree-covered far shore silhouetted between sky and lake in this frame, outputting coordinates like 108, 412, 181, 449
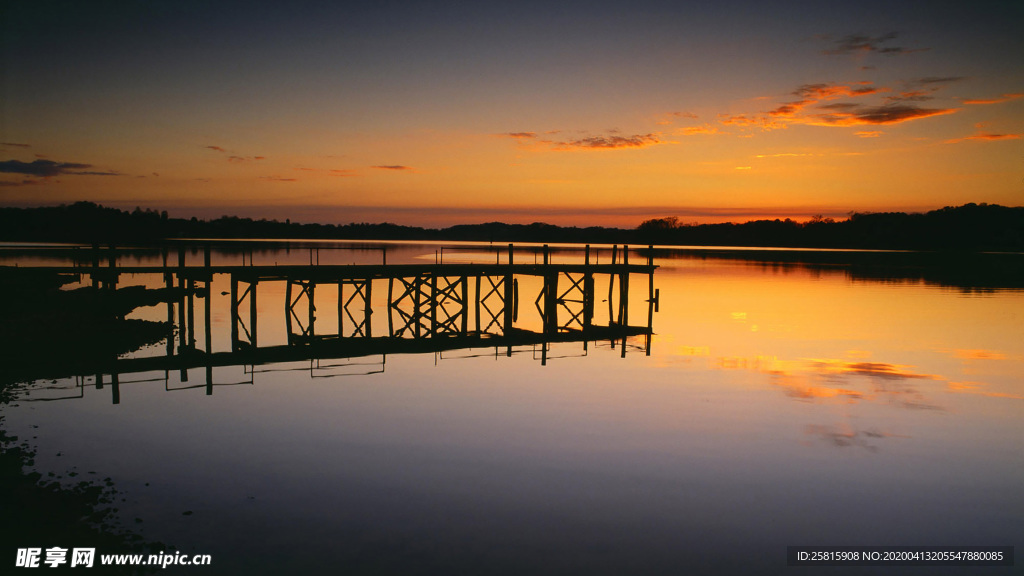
0, 202, 1024, 252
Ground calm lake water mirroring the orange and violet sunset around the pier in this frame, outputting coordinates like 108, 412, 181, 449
2, 239, 1024, 574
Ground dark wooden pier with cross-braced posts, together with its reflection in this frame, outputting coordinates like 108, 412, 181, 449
6, 245, 657, 402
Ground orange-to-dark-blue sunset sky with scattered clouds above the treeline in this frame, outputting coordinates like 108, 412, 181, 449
0, 0, 1024, 228
